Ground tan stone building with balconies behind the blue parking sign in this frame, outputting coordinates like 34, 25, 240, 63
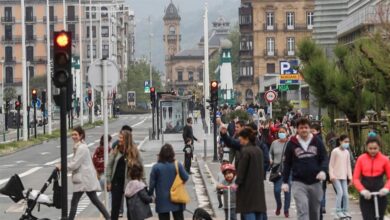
235, 0, 314, 106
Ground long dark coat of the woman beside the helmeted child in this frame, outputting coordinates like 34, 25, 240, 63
236, 145, 267, 213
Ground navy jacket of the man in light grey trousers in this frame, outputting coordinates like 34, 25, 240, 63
283, 135, 328, 185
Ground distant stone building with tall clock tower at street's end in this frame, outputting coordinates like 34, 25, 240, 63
163, 1, 230, 94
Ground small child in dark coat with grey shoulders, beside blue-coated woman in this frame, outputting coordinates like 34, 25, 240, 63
125, 164, 153, 220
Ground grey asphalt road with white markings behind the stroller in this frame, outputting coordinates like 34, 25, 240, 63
0, 115, 151, 220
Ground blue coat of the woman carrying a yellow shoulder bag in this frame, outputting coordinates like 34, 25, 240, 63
149, 163, 189, 213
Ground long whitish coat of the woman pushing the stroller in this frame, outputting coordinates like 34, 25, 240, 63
68, 142, 101, 192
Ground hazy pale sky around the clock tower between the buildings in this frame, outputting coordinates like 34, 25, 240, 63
127, 0, 240, 71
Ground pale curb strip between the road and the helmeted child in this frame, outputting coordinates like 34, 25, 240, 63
196, 156, 224, 219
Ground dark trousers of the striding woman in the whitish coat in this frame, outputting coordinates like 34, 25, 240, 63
68, 191, 110, 220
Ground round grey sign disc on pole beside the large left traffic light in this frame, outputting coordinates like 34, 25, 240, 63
88, 60, 119, 92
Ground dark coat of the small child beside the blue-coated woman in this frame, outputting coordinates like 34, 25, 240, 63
127, 188, 153, 220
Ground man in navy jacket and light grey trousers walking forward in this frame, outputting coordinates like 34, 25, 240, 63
282, 118, 328, 220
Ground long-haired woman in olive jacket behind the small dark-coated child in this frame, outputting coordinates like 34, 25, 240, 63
106, 130, 142, 220
